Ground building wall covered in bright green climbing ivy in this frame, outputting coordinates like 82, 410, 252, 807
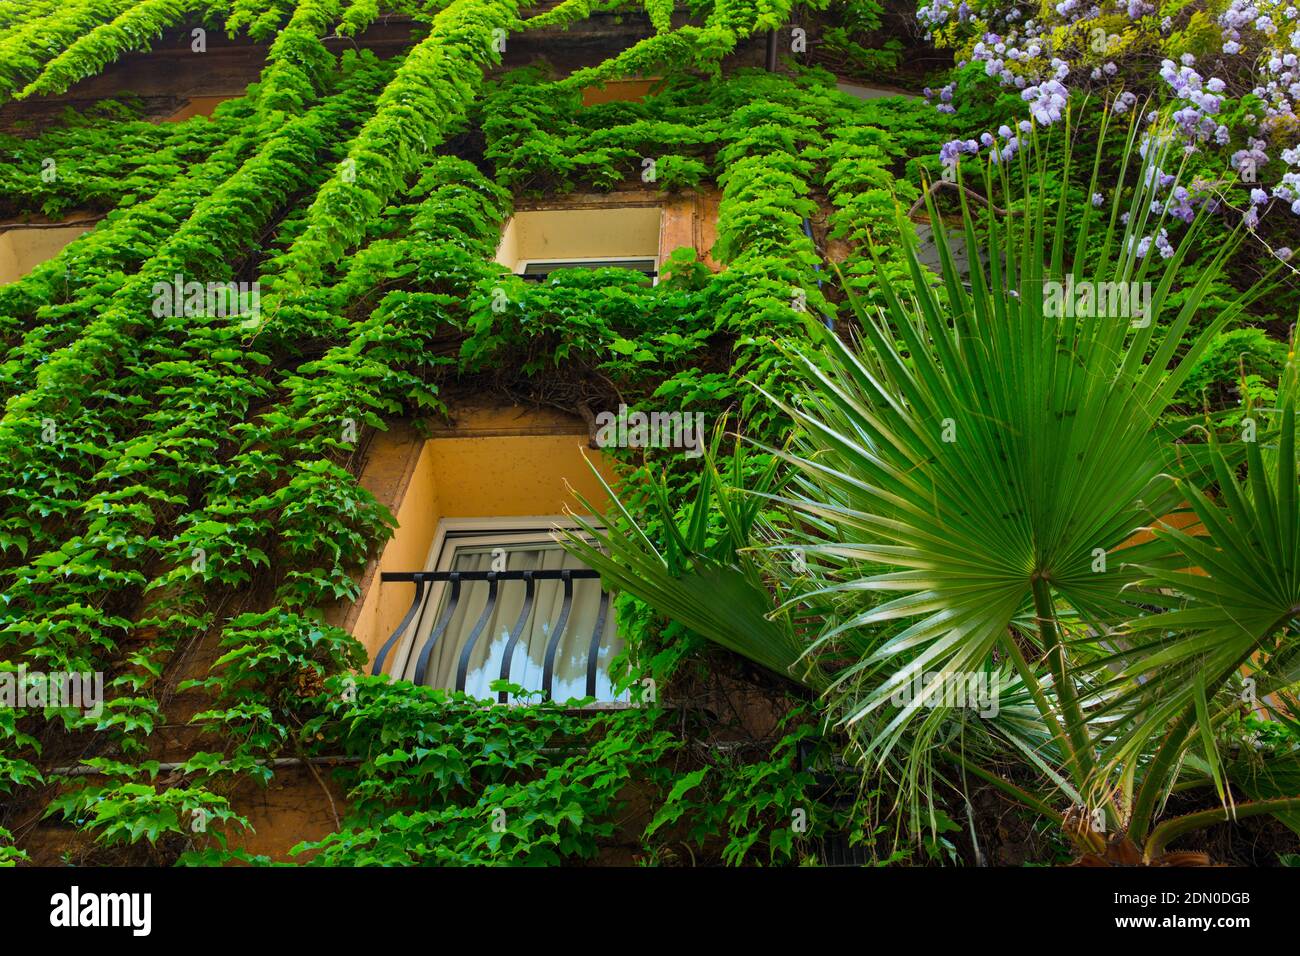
0, 0, 977, 864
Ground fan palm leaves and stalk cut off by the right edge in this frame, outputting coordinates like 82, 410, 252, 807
1101, 374, 1300, 860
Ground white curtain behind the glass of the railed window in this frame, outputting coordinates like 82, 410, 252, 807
392, 541, 621, 701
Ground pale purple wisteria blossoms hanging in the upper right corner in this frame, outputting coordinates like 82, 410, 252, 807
918, 0, 1300, 244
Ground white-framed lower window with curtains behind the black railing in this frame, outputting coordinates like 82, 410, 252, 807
374, 518, 621, 702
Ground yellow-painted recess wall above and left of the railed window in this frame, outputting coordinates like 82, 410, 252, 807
345, 412, 614, 661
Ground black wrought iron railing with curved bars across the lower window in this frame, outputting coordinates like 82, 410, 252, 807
371, 567, 610, 704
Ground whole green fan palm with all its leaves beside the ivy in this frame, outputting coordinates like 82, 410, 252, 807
569, 104, 1300, 858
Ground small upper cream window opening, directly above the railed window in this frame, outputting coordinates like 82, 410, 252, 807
497, 206, 662, 281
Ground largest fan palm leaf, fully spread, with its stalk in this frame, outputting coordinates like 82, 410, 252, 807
774, 108, 1245, 806
